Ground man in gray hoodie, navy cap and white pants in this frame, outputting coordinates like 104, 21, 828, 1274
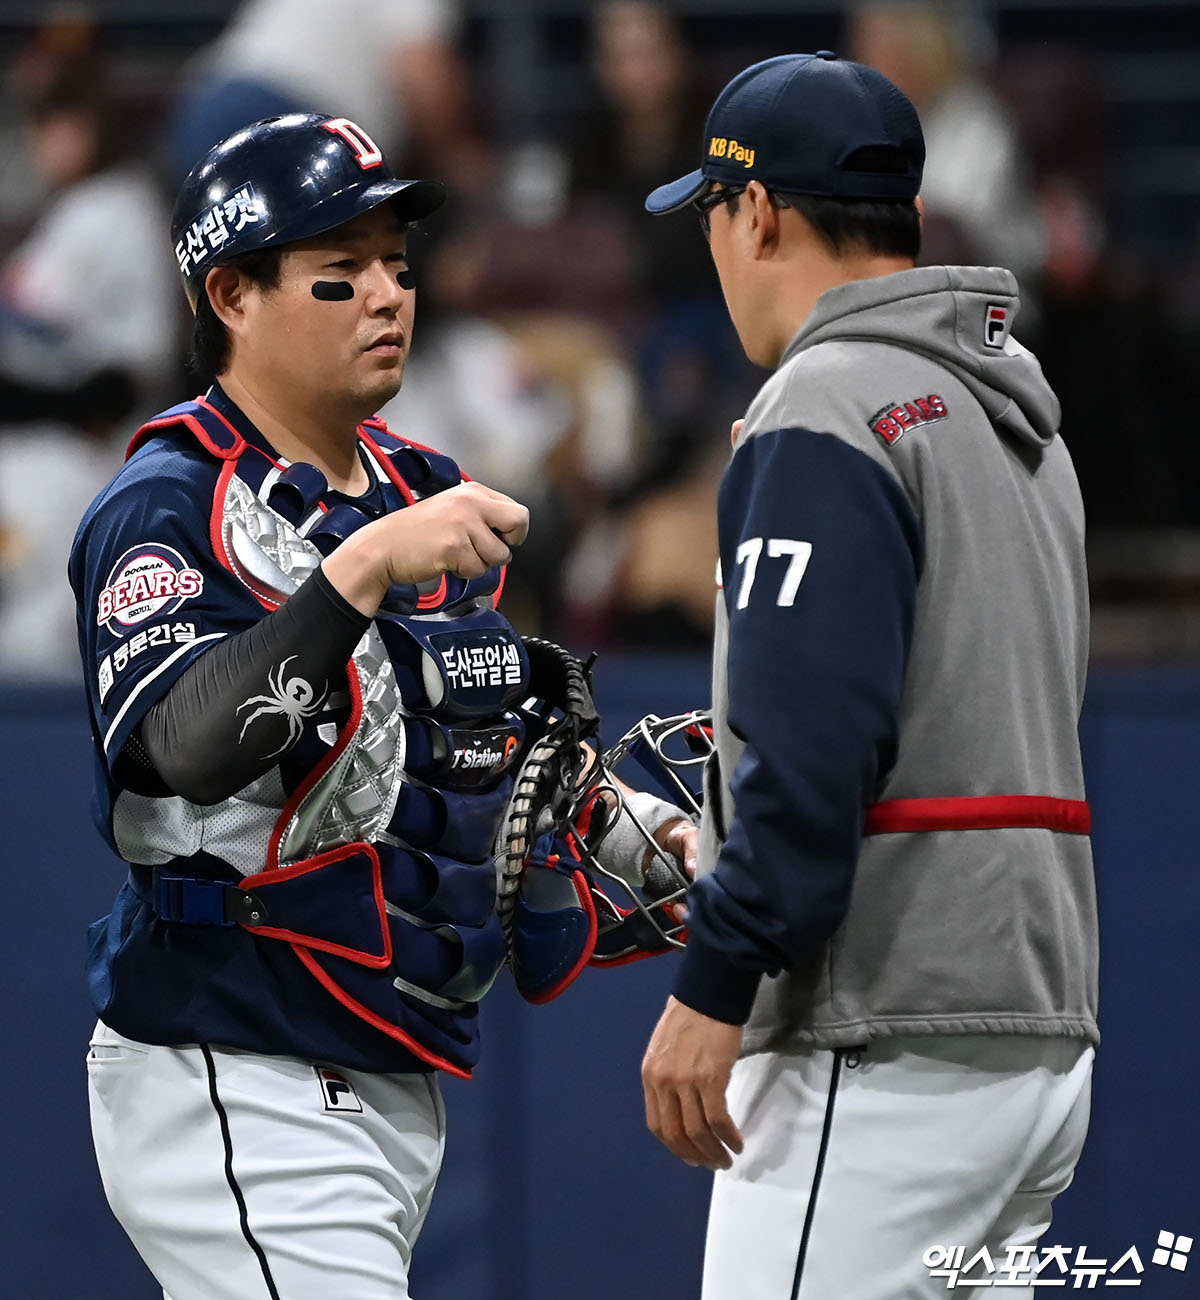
644, 51, 1099, 1300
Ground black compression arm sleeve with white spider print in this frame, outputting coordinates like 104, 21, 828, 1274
140, 569, 371, 803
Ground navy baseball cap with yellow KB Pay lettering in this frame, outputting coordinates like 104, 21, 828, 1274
646, 49, 924, 216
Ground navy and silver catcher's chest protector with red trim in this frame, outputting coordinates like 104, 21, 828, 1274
122, 402, 529, 1075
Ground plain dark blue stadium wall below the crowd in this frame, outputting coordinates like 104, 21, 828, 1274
0, 659, 1200, 1300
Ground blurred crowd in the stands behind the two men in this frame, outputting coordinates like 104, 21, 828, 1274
0, 0, 1200, 680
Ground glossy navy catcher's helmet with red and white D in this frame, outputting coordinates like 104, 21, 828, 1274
170, 113, 446, 302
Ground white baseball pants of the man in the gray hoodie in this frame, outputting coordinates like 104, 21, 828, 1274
702, 1035, 1095, 1300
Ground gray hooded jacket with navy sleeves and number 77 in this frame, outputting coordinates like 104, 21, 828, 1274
676, 267, 1099, 1052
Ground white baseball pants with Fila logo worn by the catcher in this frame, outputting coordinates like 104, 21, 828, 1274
87, 1024, 446, 1300
